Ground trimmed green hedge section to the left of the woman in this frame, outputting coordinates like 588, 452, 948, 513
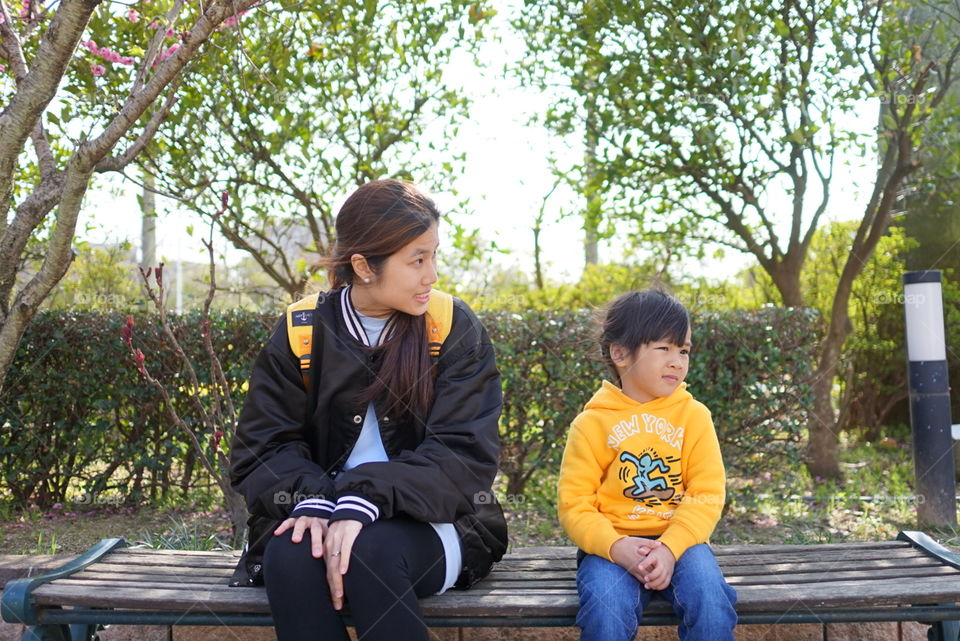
0, 311, 272, 507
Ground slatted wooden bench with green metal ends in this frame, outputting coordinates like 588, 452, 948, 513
3, 532, 960, 641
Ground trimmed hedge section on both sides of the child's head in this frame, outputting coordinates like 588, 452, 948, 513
481, 308, 819, 497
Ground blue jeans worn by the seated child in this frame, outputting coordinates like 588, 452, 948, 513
577, 543, 737, 641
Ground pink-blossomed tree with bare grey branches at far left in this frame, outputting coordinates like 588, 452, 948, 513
0, 0, 266, 385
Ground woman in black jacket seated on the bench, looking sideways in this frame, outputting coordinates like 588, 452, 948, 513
231, 180, 506, 641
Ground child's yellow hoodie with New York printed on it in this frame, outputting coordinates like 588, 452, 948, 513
559, 381, 726, 561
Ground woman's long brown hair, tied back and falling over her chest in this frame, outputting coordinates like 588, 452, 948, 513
326, 180, 440, 420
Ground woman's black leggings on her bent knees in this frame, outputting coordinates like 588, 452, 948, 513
263, 518, 446, 641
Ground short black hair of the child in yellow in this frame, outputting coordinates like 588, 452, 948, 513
600, 289, 690, 383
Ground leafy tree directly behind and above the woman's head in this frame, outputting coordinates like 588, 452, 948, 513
141, 0, 490, 299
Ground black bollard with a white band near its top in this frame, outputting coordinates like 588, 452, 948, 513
903, 270, 957, 527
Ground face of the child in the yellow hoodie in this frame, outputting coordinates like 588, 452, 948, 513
610, 329, 690, 403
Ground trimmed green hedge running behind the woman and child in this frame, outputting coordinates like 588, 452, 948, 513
0, 309, 817, 507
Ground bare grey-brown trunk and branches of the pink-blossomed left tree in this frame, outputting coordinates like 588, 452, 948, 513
0, 0, 255, 392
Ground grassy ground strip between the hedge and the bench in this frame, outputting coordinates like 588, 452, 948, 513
0, 439, 960, 554
